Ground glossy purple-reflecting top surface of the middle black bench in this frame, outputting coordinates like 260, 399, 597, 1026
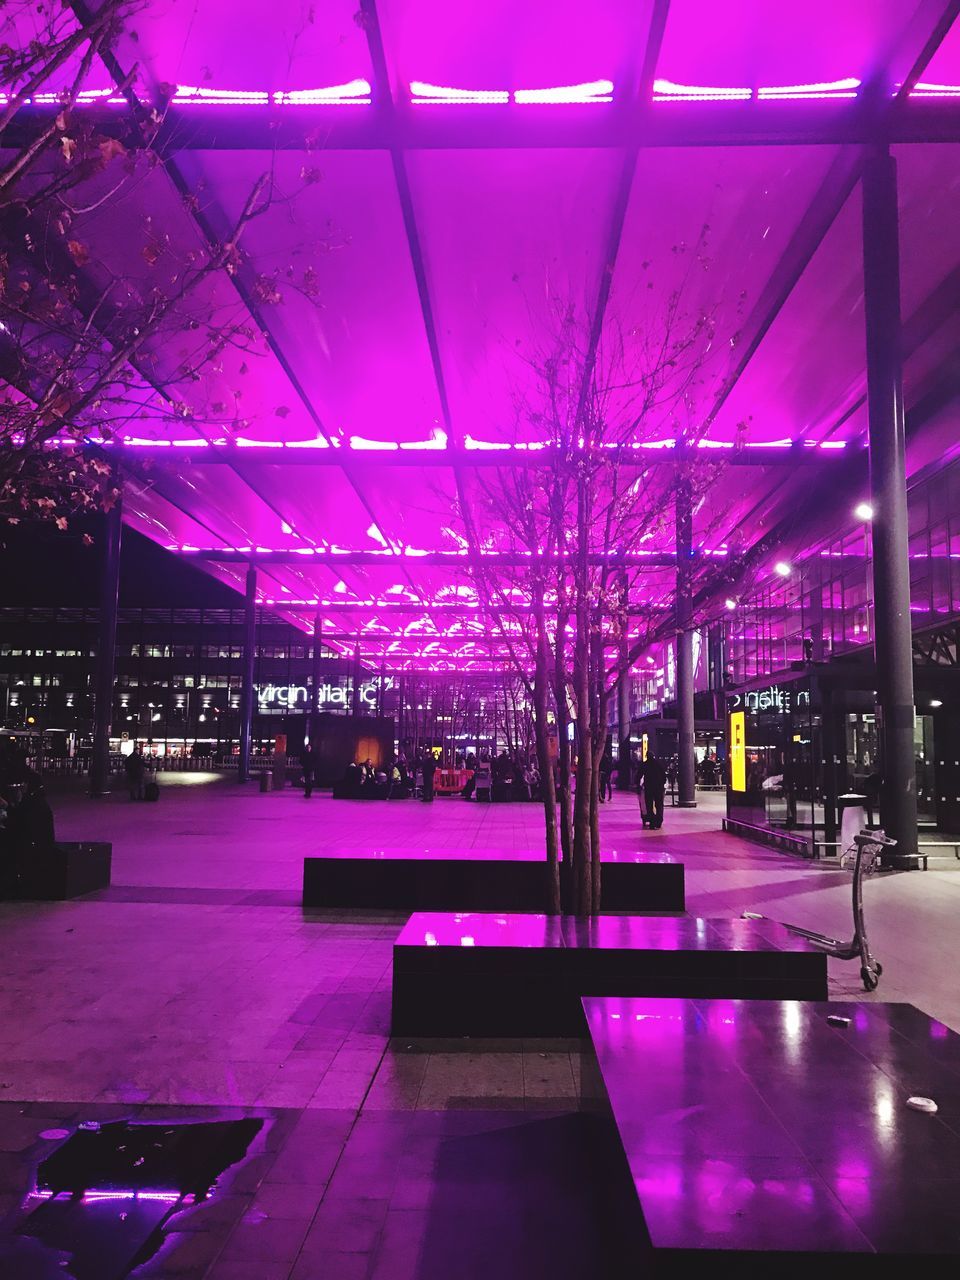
396, 911, 812, 952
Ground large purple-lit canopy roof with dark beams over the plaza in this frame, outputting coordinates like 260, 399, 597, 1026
5, 0, 960, 669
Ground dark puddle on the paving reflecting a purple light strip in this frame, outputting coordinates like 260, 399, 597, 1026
0, 1119, 264, 1280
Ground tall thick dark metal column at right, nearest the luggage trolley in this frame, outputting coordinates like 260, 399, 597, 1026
863, 148, 916, 868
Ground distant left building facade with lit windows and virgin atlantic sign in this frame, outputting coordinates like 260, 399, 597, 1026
0, 607, 396, 759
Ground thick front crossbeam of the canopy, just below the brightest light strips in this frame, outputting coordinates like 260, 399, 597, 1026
5, 99, 960, 156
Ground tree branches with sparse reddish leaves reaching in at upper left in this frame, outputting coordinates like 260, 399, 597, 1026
0, 0, 327, 529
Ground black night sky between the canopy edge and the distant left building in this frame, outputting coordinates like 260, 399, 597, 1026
0, 518, 242, 608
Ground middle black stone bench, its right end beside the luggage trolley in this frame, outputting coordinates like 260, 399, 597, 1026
392, 913, 827, 1037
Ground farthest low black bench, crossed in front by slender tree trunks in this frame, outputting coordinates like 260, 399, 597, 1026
303, 849, 685, 913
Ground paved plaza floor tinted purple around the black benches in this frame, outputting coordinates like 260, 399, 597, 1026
0, 774, 960, 1280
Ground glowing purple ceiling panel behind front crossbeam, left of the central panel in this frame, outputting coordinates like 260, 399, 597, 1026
182, 151, 442, 449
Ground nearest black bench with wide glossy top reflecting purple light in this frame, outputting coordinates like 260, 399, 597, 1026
582, 997, 960, 1280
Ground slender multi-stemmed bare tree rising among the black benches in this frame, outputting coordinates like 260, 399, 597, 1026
472, 255, 732, 914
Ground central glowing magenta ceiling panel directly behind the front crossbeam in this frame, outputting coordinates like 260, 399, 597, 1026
408, 150, 622, 443
